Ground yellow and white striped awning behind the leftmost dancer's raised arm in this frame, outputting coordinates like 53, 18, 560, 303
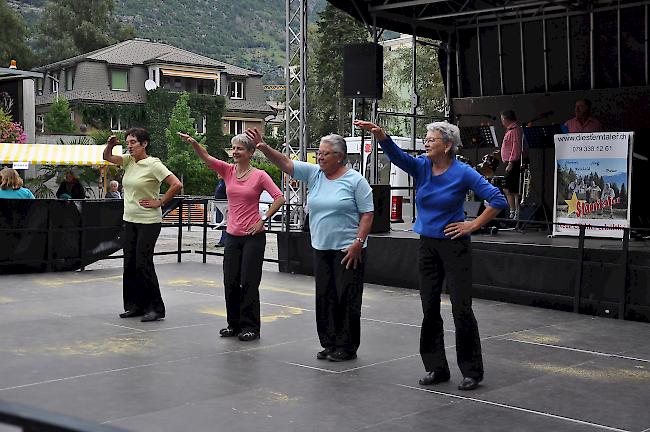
0, 143, 122, 165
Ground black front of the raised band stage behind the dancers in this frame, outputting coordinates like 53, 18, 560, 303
278, 230, 650, 321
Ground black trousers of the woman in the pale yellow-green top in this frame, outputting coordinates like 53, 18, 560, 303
123, 221, 165, 315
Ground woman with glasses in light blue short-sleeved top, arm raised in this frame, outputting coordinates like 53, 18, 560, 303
246, 129, 374, 361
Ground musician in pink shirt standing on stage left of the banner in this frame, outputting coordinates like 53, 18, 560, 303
501, 110, 523, 219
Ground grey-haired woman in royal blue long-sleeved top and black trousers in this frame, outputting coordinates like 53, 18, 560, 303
354, 121, 508, 390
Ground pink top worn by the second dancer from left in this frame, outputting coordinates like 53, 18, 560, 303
209, 159, 282, 236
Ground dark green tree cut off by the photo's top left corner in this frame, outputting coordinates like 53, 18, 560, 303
0, 0, 34, 69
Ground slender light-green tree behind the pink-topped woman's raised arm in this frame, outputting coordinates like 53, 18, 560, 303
165, 92, 209, 194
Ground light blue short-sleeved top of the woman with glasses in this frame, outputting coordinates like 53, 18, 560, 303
293, 161, 374, 250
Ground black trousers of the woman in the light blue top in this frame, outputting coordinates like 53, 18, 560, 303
314, 249, 366, 353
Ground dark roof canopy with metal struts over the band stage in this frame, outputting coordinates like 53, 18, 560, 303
329, 0, 650, 98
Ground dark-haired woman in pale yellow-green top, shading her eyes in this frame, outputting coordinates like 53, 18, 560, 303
104, 128, 183, 322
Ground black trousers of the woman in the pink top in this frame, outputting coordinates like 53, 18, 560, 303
223, 233, 266, 332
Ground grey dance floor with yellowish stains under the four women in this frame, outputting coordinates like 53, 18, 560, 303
0, 258, 650, 432
